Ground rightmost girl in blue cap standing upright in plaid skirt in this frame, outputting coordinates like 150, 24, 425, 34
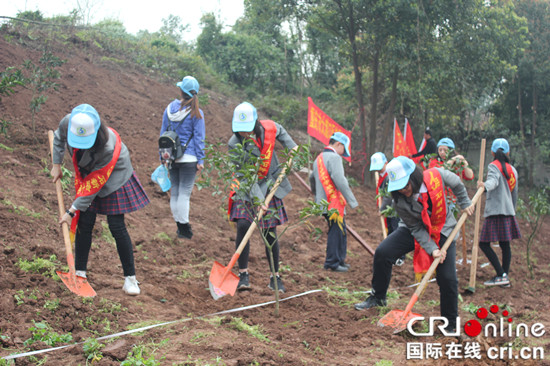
477, 138, 521, 287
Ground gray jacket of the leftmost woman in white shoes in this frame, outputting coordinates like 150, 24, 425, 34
53, 114, 134, 211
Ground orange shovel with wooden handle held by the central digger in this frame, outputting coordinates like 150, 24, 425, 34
208, 158, 292, 300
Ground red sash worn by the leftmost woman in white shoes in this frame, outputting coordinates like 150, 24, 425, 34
71, 127, 122, 241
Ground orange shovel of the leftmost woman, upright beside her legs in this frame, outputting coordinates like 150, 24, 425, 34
48, 130, 96, 297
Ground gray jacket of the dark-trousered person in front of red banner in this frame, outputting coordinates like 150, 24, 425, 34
309, 149, 359, 213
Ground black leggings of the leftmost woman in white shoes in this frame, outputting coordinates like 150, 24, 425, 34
75, 211, 136, 276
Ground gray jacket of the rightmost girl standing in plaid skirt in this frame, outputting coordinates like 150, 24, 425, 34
483, 162, 518, 217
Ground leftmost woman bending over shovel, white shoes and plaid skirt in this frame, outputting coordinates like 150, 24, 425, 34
51, 104, 149, 295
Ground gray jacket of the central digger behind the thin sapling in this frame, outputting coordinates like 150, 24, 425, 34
228, 122, 297, 202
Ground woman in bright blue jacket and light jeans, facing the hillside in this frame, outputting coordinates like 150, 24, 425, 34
160, 76, 205, 239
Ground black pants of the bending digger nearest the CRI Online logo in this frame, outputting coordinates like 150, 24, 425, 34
372, 227, 458, 327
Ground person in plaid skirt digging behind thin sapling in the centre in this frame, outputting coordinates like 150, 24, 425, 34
228, 102, 298, 292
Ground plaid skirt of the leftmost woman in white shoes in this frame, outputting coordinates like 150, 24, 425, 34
88, 172, 149, 215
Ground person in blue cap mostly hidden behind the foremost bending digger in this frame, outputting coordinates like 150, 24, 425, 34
369, 152, 405, 266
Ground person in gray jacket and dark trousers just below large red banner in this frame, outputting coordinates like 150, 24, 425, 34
309, 132, 359, 272
